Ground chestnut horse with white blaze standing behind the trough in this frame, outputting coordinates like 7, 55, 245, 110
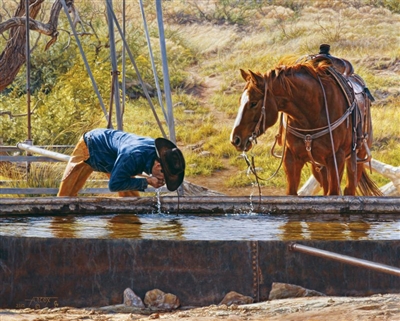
230, 59, 382, 196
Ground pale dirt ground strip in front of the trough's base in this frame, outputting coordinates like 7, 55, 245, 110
0, 294, 400, 321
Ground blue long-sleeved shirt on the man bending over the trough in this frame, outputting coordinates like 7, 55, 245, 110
83, 129, 156, 192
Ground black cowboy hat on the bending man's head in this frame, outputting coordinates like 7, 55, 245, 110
155, 138, 185, 191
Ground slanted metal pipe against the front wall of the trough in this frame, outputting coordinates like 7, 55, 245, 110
289, 243, 400, 276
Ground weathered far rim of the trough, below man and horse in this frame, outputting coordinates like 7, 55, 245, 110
0, 194, 400, 215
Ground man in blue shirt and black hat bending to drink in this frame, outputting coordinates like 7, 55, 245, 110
57, 129, 185, 197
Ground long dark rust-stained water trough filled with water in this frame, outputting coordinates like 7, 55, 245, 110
0, 196, 400, 308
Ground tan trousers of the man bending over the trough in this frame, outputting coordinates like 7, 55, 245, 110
57, 137, 140, 197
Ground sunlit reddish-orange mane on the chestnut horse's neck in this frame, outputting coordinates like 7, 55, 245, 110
265, 56, 332, 95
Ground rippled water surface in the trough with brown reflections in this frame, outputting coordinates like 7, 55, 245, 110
0, 213, 400, 241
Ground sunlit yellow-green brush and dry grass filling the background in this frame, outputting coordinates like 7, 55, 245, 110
0, 0, 400, 194
